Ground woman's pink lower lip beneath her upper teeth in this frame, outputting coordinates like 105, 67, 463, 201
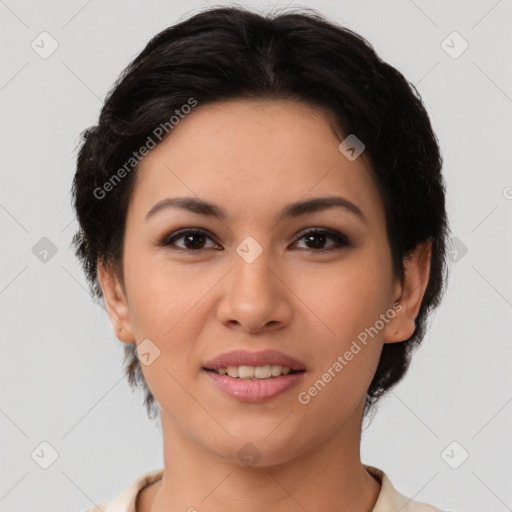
204, 370, 304, 403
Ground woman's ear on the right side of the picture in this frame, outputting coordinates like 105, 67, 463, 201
384, 240, 432, 343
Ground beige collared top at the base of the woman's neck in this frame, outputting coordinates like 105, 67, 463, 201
80, 464, 443, 512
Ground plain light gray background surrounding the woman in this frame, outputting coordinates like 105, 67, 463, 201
0, 0, 512, 512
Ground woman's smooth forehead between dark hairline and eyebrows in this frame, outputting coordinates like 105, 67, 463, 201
130, 100, 383, 226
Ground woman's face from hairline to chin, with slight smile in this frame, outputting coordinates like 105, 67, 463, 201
101, 101, 411, 464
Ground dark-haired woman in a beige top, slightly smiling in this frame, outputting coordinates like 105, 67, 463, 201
73, 8, 448, 512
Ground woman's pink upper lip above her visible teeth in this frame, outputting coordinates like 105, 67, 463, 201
203, 350, 305, 371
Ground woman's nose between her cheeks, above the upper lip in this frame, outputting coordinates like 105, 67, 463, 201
217, 246, 293, 334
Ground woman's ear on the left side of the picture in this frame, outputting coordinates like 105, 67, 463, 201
98, 260, 135, 343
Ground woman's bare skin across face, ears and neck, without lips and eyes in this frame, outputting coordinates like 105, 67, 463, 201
98, 100, 431, 512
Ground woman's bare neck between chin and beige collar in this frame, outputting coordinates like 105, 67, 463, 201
144, 400, 380, 512
